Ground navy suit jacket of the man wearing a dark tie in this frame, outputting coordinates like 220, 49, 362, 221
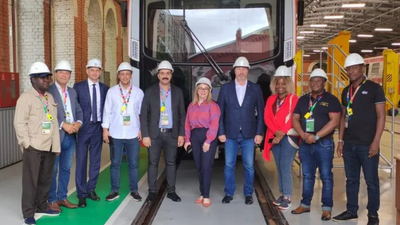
74, 80, 108, 135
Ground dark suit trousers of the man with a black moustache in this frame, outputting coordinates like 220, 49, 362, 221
147, 131, 178, 193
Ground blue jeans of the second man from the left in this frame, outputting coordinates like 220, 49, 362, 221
48, 133, 75, 203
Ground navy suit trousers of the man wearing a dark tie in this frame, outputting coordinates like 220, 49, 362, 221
75, 123, 103, 198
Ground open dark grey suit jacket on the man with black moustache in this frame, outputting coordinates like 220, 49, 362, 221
140, 83, 185, 138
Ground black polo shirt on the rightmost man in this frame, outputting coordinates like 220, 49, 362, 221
342, 80, 386, 145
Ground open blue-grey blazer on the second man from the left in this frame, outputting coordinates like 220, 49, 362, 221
47, 83, 83, 142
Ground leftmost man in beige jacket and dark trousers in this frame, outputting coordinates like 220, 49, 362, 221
14, 62, 60, 224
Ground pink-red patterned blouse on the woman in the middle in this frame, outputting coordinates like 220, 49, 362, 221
185, 101, 221, 144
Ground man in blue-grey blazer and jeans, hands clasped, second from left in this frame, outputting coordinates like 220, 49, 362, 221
48, 60, 83, 212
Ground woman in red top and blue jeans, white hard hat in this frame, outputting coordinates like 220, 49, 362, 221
263, 66, 299, 209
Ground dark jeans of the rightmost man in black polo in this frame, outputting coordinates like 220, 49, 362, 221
343, 142, 380, 216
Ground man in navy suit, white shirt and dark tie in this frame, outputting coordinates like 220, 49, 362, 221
74, 59, 108, 207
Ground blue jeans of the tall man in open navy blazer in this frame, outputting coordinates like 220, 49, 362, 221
224, 132, 254, 196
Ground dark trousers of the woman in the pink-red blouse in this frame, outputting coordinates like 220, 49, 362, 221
190, 128, 217, 198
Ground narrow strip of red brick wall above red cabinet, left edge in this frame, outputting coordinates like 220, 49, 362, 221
0, 0, 11, 72
